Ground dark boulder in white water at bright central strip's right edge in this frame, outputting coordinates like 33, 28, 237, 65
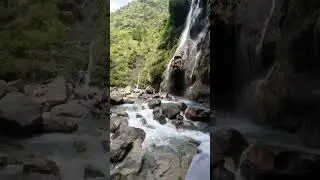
185, 107, 210, 122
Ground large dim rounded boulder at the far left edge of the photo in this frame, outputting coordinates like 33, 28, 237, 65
0, 92, 42, 135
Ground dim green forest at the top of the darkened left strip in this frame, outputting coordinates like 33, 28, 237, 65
0, 0, 109, 85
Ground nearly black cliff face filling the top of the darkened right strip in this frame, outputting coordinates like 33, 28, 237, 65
211, 0, 320, 146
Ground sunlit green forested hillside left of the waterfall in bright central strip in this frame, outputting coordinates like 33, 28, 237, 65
110, 0, 190, 87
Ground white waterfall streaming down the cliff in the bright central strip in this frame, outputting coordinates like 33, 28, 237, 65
165, 0, 210, 93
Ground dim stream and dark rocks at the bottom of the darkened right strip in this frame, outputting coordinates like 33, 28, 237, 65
211, 117, 320, 180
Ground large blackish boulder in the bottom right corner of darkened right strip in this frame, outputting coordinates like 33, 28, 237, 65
239, 143, 320, 180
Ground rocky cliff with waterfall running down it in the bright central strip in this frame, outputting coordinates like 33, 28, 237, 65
166, 0, 211, 103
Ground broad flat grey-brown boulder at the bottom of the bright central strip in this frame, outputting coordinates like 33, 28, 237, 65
111, 140, 196, 180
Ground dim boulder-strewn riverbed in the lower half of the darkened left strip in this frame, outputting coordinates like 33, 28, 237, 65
0, 77, 109, 180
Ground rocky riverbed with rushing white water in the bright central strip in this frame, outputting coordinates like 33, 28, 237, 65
110, 87, 213, 180
